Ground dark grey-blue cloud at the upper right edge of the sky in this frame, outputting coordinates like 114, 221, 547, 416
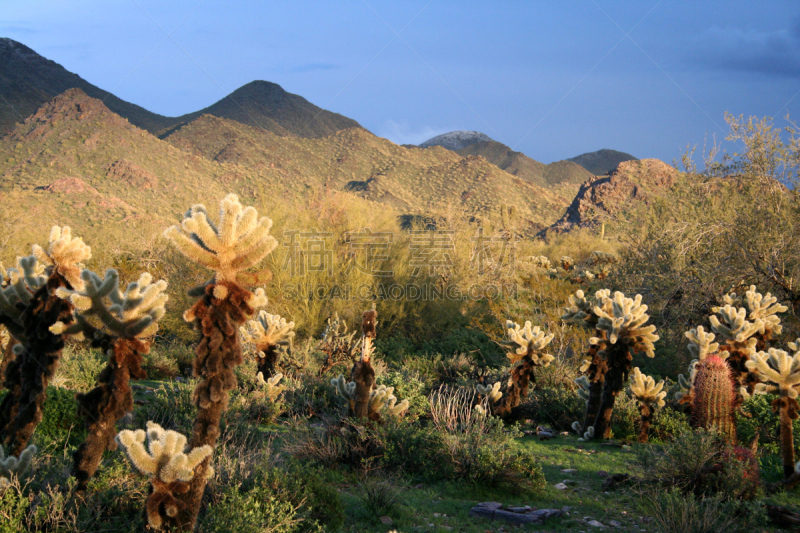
690, 19, 800, 78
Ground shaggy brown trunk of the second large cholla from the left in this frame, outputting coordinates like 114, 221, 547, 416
73, 338, 152, 490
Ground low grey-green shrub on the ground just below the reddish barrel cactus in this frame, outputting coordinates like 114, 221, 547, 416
638, 429, 759, 500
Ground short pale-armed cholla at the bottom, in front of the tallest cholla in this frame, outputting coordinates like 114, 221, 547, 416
117, 422, 214, 529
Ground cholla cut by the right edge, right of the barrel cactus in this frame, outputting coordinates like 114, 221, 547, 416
747, 339, 800, 478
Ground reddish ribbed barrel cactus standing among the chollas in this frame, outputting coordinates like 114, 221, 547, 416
692, 355, 736, 442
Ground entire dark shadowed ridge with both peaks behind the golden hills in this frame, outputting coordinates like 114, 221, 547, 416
0, 38, 360, 138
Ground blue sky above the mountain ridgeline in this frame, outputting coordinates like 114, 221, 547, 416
0, 0, 800, 163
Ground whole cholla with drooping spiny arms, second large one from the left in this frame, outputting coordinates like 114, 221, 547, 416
50, 269, 167, 490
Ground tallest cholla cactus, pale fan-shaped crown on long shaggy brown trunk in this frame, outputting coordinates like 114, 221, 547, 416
164, 194, 278, 531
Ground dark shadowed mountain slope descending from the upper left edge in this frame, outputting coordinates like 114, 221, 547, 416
0, 38, 173, 135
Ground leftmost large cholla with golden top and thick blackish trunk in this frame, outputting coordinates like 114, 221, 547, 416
0, 226, 91, 455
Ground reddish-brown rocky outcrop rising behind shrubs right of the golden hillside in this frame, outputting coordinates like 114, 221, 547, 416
547, 159, 678, 233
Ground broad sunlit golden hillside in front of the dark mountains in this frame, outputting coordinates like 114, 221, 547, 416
0, 89, 566, 264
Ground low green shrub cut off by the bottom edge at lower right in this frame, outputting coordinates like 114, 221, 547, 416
643, 489, 754, 533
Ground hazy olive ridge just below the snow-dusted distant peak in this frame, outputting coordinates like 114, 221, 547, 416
456, 140, 592, 202
